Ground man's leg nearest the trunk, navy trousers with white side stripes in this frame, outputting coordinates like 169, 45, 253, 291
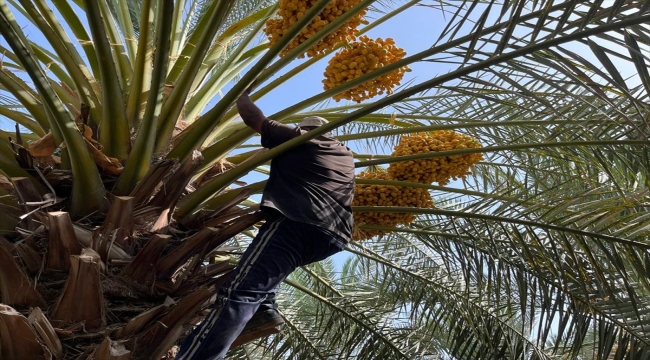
176, 219, 304, 360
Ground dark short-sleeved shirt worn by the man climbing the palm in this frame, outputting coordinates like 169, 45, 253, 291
261, 120, 354, 241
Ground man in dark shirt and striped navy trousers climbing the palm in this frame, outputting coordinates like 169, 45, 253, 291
176, 89, 354, 360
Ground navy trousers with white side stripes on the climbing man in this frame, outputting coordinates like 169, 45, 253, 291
176, 217, 345, 360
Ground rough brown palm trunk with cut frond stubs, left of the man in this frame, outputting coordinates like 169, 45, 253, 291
0, 143, 274, 360
